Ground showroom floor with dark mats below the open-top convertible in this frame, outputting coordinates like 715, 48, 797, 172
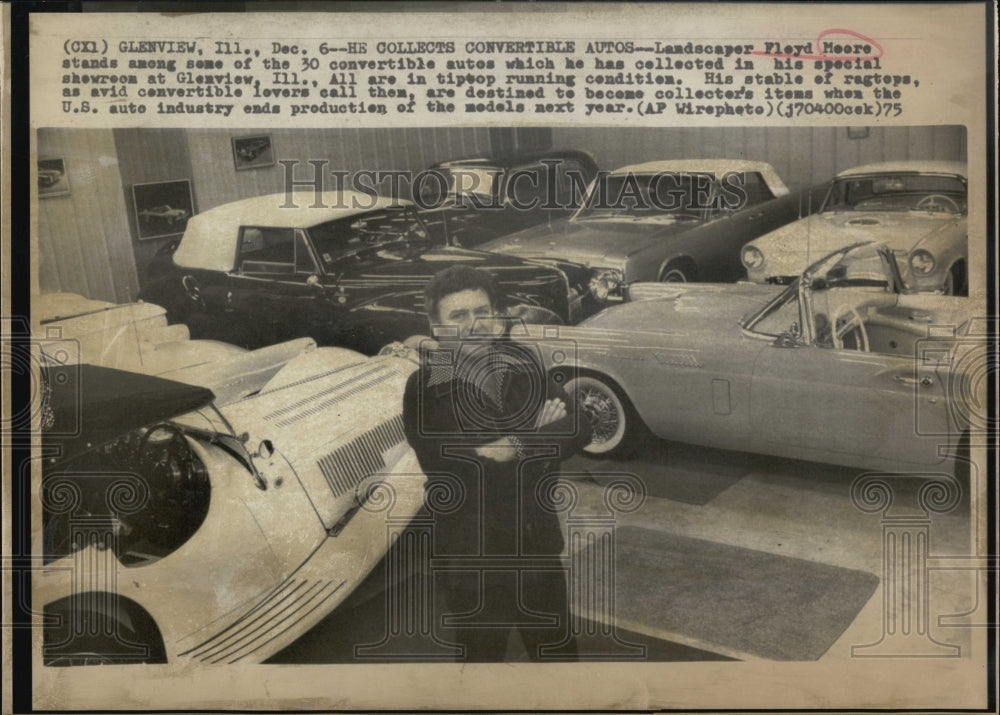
272, 440, 982, 662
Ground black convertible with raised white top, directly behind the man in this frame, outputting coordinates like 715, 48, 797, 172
141, 191, 583, 355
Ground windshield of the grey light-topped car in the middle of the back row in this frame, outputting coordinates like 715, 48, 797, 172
573, 172, 718, 221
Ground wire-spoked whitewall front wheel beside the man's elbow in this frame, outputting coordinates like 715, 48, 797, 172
566, 374, 642, 457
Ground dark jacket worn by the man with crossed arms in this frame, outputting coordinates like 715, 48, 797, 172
403, 339, 591, 557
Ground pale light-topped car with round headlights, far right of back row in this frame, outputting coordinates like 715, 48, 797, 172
741, 161, 969, 295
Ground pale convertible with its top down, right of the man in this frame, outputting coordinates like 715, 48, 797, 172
532, 243, 986, 470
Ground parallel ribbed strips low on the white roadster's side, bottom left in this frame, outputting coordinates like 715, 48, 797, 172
180, 578, 344, 663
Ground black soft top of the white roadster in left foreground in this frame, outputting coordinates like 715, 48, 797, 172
42, 365, 215, 461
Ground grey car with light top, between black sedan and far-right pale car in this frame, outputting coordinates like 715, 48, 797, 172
481, 159, 828, 300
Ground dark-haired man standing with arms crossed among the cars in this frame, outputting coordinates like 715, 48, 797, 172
403, 266, 590, 662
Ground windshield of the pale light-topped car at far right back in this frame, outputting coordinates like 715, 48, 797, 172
823, 174, 966, 214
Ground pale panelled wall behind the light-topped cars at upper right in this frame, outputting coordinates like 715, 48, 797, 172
552, 126, 966, 188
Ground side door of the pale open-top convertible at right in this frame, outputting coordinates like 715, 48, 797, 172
750, 341, 946, 466
